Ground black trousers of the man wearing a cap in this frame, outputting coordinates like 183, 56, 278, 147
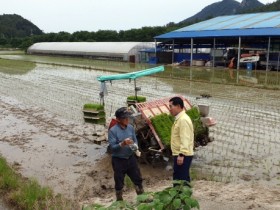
112, 155, 143, 191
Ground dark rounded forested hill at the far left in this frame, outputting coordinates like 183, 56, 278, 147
0, 14, 43, 38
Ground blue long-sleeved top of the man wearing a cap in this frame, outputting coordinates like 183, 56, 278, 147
108, 124, 138, 159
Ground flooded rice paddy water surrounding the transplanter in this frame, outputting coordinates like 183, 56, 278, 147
0, 56, 280, 209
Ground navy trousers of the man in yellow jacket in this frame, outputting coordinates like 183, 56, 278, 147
173, 156, 193, 183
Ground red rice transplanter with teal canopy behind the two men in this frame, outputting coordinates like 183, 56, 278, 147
97, 66, 216, 165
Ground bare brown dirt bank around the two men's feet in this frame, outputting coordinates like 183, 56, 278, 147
80, 156, 280, 210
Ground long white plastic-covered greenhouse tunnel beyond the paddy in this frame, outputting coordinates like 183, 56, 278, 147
27, 42, 155, 63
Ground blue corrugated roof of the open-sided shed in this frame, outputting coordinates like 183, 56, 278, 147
155, 11, 280, 39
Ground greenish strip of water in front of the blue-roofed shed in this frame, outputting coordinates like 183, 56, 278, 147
160, 66, 280, 89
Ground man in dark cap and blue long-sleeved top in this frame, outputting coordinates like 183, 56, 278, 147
108, 107, 144, 201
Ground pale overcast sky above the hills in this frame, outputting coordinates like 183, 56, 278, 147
0, 0, 276, 33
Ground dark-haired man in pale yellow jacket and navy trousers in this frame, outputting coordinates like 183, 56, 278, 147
169, 97, 194, 185
